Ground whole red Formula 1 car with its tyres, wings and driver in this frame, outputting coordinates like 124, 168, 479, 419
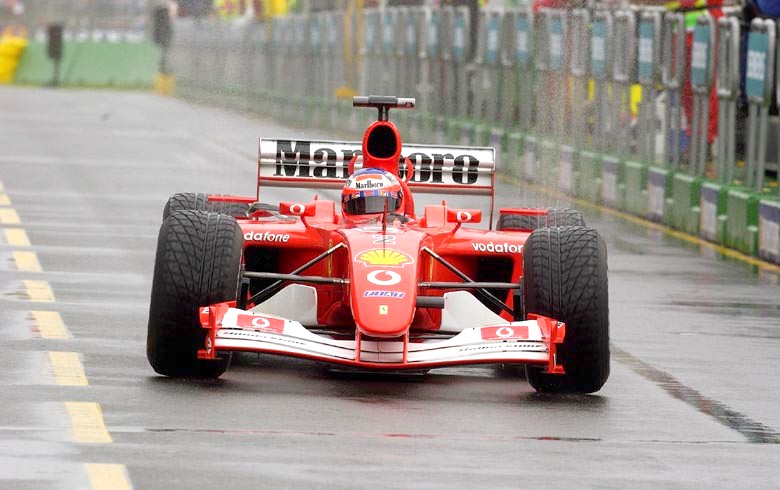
147, 96, 609, 393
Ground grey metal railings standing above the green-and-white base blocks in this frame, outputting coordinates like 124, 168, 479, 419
172, 7, 780, 196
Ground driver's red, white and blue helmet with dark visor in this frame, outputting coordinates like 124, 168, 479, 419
341, 168, 403, 216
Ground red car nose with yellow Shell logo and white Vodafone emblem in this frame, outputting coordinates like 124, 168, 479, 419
345, 229, 424, 337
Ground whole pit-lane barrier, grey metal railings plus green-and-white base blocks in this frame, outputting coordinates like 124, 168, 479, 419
171, 7, 780, 263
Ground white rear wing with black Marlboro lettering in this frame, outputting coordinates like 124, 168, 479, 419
257, 139, 495, 197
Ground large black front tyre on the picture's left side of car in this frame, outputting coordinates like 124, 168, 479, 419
146, 211, 243, 378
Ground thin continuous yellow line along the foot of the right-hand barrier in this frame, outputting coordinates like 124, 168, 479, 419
499, 175, 780, 273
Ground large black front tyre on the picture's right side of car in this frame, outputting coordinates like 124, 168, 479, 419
523, 227, 609, 393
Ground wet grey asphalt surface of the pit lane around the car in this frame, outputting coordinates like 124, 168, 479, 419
0, 88, 780, 490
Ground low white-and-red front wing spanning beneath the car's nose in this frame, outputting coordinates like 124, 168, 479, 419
198, 302, 566, 374
